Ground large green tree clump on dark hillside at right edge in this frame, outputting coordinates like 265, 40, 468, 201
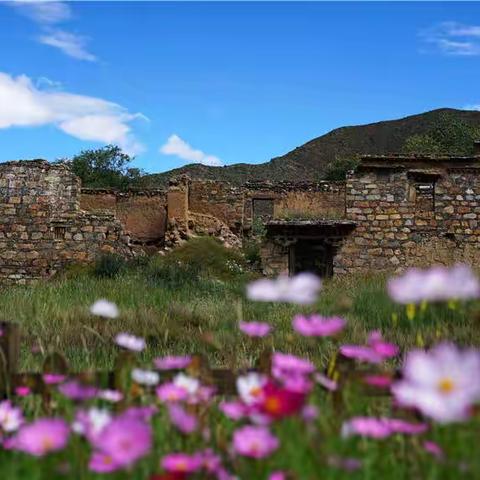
403, 113, 480, 155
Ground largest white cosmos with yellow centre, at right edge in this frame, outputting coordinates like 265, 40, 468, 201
392, 343, 480, 423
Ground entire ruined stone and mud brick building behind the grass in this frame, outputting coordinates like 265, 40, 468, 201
0, 155, 480, 283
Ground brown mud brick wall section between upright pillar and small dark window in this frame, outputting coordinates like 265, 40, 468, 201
188, 180, 244, 234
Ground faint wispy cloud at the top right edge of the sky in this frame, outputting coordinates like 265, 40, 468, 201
420, 22, 480, 57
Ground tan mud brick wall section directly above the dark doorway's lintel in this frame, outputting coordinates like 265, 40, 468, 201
244, 182, 345, 229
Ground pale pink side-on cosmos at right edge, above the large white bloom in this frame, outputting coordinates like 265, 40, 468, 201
387, 265, 480, 304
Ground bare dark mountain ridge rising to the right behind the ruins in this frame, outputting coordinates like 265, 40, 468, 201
146, 108, 480, 186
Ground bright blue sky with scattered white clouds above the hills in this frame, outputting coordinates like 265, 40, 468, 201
0, 1, 480, 172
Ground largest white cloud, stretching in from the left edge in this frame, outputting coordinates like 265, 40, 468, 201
0, 72, 145, 155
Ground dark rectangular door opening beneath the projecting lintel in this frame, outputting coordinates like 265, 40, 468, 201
289, 239, 335, 277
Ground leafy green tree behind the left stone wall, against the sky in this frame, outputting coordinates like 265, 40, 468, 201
68, 145, 143, 190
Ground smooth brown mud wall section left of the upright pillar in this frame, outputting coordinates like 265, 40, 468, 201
80, 188, 167, 245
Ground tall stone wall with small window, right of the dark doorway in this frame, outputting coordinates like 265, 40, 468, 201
335, 158, 480, 273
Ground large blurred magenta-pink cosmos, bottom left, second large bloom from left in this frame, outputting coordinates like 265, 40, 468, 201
92, 414, 152, 467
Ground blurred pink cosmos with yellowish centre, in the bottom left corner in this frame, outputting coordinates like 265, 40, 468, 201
11, 418, 70, 457
